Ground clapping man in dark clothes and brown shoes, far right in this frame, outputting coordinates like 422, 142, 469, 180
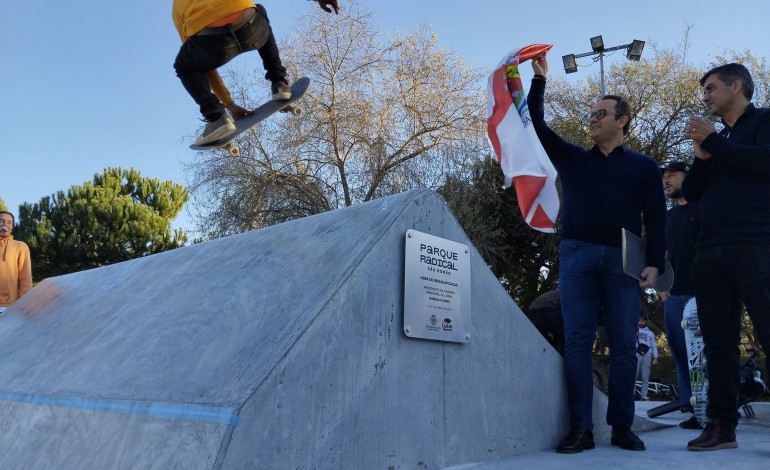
682, 64, 770, 450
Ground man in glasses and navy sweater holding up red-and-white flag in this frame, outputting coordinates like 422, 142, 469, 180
528, 55, 666, 453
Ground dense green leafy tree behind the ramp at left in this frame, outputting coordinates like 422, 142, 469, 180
17, 168, 188, 280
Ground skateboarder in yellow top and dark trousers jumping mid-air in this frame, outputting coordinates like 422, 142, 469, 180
172, 0, 339, 145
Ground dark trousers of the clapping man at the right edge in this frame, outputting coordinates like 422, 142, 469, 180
693, 243, 770, 425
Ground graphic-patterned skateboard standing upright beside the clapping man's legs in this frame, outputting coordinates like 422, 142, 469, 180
682, 299, 708, 426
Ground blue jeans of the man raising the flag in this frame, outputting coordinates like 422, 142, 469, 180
559, 240, 641, 429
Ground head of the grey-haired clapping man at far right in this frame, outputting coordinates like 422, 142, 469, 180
700, 63, 754, 117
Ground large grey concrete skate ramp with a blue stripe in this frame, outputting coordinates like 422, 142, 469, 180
0, 190, 584, 469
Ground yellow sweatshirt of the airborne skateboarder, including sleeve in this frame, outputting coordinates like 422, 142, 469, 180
171, 0, 254, 106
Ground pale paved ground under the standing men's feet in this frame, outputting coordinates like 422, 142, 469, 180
444, 402, 770, 470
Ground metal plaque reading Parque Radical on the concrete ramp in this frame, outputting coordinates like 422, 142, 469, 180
404, 230, 471, 343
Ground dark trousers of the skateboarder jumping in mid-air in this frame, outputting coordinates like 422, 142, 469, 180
174, 5, 286, 122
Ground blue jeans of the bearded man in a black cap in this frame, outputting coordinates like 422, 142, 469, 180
663, 295, 693, 412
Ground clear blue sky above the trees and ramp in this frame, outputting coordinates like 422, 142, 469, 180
0, 0, 770, 232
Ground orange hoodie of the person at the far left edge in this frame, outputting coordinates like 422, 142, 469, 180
0, 235, 32, 307
